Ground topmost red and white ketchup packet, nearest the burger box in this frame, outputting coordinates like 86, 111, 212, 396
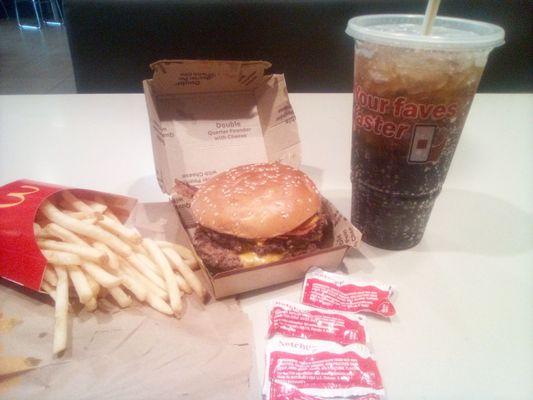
302, 268, 396, 317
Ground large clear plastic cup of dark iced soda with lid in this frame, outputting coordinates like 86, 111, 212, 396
346, 15, 504, 249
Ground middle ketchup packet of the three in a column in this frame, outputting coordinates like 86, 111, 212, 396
268, 301, 367, 345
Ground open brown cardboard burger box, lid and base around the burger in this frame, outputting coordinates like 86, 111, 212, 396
143, 60, 361, 299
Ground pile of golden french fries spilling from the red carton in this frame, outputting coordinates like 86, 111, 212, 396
37, 191, 207, 355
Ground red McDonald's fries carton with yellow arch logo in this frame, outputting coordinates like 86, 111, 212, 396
0, 180, 137, 291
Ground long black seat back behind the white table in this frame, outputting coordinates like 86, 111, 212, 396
59, 0, 533, 93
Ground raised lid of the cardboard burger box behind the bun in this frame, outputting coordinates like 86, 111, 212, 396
143, 60, 301, 194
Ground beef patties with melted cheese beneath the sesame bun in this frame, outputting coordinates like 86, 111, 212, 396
194, 212, 333, 272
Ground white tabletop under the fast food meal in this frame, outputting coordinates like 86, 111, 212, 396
0, 94, 533, 400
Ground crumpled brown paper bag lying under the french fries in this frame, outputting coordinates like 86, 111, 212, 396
0, 200, 253, 400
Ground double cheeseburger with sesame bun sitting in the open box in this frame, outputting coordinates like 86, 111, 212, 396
191, 163, 332, 273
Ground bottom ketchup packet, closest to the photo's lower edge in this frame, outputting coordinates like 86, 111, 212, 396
263, 336, 385, 400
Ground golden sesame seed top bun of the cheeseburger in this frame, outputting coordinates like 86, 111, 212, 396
191, 163, 320, 239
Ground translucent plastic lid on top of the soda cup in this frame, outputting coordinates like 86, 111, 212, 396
346, 14, 505, 50
